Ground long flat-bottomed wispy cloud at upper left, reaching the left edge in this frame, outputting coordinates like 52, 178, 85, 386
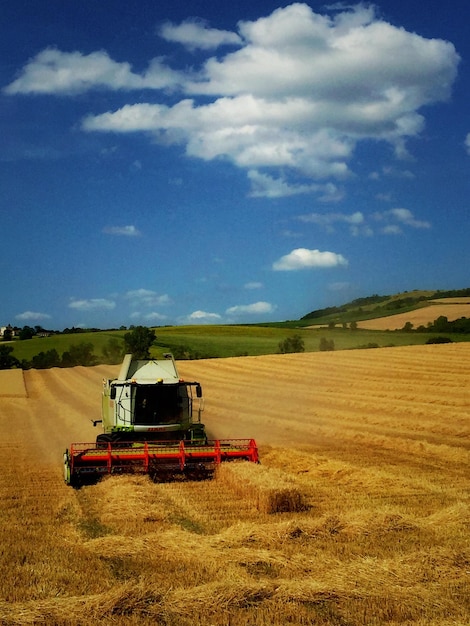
4, 48, 180, 95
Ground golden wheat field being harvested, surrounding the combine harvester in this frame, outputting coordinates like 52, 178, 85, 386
0, 343, 470, 626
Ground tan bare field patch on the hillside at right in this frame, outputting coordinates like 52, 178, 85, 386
357, 302, 470, 330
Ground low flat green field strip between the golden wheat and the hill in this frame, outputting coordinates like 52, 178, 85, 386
8, 325, 467, 361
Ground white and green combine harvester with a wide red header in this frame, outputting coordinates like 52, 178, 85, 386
64, 354, 258, 486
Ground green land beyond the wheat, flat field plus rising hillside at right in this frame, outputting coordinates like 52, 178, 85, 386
9, 289, 470, 363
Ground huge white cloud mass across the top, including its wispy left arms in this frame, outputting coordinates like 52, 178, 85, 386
5, 2, 459, 190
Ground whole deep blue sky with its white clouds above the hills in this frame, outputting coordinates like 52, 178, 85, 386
0, 0, 470, 329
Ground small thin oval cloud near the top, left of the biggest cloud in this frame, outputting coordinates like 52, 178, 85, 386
160, 20, 242, 50
